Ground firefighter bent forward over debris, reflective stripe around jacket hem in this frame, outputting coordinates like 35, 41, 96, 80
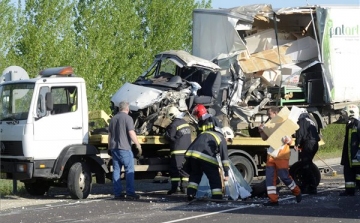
183, 128, 230, 201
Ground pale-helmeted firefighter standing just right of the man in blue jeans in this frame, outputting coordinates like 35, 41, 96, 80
165, 106, 191, 195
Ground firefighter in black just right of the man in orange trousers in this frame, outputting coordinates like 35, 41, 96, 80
295, 108, 320, 194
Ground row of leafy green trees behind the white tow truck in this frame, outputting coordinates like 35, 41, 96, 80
0, 0, 211, 111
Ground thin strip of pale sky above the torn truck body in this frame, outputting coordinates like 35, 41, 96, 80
211, 0, 360, 9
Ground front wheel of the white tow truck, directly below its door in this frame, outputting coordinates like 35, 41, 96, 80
67, 162, 92, 199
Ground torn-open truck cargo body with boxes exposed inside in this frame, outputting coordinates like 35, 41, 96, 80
193, 4, 360, 130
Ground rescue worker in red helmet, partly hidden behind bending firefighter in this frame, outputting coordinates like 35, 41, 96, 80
193, 104, 222, 135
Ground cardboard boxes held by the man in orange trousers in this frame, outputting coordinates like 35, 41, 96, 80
264, 106, 300, 149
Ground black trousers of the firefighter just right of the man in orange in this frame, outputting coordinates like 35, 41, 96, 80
299, 140, 319, 193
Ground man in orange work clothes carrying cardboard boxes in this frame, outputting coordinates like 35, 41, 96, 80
259, 107, 302, 206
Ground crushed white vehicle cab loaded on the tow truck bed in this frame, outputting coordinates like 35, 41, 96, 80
111, 50, 221, 135
